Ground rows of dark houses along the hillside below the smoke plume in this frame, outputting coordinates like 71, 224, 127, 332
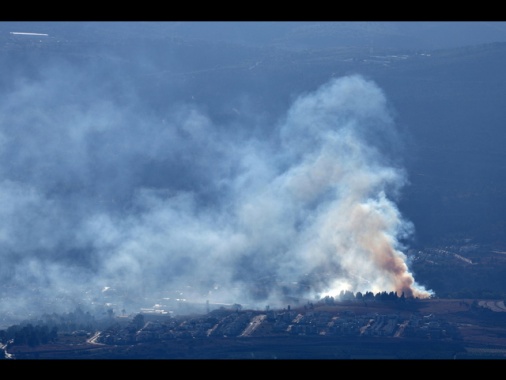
93, 302, 458, 344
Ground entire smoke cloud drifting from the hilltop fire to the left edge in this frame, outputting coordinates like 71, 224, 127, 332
0, 55, 430, 320
